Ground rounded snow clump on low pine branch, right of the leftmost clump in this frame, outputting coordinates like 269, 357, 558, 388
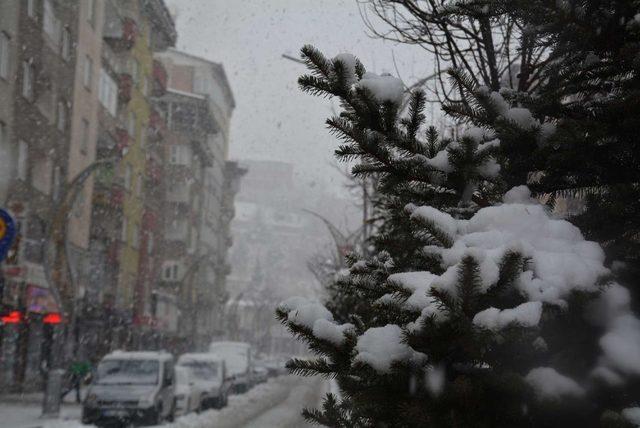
354, 324, 426, 373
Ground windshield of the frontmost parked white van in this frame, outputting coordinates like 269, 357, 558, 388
97, 360, 160, 385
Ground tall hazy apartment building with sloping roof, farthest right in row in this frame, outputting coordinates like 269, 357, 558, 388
156, 49, 238, 347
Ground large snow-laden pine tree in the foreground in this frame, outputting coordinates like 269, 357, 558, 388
277, 47, 640, 427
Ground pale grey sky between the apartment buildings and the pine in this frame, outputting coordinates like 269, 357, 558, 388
168, 0, 431, 192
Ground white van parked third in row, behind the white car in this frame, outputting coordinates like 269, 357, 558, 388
209, 342, 253, 394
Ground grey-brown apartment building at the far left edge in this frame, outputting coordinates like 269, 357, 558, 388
0, 0, 78, 389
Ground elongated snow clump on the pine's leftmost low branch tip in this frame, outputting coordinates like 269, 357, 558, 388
278, 297, 353, 346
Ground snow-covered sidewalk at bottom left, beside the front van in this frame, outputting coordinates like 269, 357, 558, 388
0, 392, 86, 428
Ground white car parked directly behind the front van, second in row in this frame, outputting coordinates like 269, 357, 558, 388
178, 353, 232, 409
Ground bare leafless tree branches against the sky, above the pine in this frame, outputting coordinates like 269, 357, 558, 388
358, 0, 550, 102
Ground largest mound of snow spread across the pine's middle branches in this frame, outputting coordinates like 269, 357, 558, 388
397, 186, 609, 305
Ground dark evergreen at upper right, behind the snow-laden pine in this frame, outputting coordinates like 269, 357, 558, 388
442, 0, 640, 290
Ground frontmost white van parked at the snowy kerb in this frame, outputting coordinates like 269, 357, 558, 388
82, 351, 175, 425
